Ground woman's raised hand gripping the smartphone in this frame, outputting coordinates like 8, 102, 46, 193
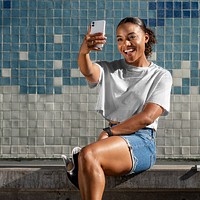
79, 27, 107, 54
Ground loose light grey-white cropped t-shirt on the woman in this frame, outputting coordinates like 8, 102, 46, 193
89, 59, 172, 130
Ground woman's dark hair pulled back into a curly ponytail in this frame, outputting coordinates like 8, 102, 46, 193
117, 17, 156, 58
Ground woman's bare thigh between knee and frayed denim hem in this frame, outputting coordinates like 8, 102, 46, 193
84, 136, 133, 176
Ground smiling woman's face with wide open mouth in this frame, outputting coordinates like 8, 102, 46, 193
117, 22, 149, 66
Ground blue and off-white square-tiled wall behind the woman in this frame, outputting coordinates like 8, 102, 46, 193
0, 0, 200, 158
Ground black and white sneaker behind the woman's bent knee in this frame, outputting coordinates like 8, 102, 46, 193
61, 147, 81, 189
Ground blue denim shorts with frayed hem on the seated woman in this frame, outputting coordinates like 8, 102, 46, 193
121, 128, 156, 175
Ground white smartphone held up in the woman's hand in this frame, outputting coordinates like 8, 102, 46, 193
91, 20, 106, 49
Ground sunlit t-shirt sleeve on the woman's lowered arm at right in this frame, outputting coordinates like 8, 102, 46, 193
146, 71, 172, 116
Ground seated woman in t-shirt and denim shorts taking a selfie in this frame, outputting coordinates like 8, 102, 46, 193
62, 17, 172, 200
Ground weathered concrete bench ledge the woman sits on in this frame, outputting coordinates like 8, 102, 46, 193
0, 161, 200, 200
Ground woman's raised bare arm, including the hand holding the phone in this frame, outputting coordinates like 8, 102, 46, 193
78, 28, 106, 83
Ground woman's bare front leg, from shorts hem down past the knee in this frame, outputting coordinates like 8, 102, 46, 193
78, 136, 132, 200
